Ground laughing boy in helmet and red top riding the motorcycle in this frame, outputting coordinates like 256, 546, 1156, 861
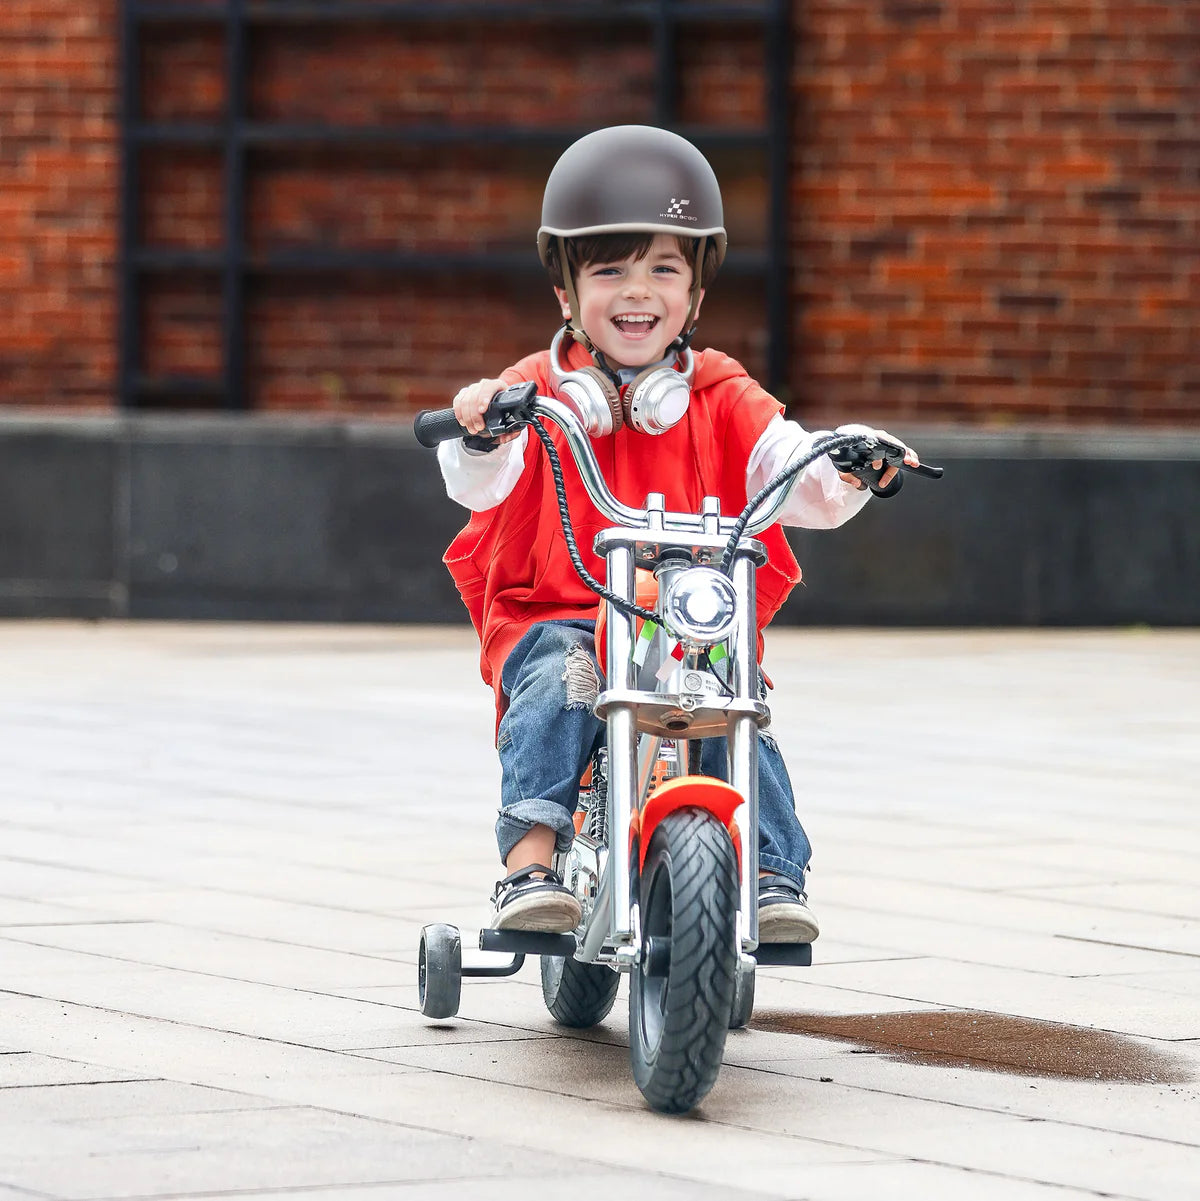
438, 125, 918, 943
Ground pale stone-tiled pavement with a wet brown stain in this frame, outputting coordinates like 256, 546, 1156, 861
0, 622, 1200, 1201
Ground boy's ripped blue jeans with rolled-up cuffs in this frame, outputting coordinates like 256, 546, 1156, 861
496, 621, 812, 886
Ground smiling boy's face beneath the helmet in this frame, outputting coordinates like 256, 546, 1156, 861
554, 233, 704, 368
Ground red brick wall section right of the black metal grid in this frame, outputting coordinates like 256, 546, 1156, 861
795, 0, 1200, 423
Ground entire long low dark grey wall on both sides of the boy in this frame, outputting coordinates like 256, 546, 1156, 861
0, 416, 1200, 625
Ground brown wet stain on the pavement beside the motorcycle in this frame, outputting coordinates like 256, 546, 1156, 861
750, 1010, 1192, 1085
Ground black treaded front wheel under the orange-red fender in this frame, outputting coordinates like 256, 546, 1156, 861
629, 809, 739, 1113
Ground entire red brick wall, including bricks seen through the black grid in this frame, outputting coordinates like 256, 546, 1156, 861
0, 0, 1200, 424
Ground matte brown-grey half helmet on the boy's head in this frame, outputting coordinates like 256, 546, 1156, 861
537, 125, 726, 264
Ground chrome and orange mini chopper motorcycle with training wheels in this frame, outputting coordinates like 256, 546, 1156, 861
414, 383, 942, 1113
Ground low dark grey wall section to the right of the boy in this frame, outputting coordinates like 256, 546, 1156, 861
781, 454, 1200, 626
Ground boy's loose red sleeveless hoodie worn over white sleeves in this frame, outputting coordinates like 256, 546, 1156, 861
443, 346, 800, 715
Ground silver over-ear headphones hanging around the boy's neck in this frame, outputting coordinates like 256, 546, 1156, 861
550, 327, 695, 438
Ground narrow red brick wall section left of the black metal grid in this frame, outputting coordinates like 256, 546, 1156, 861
0, 0, 119, 406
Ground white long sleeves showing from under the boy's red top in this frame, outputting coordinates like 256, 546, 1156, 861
437, 416, 871, 530
